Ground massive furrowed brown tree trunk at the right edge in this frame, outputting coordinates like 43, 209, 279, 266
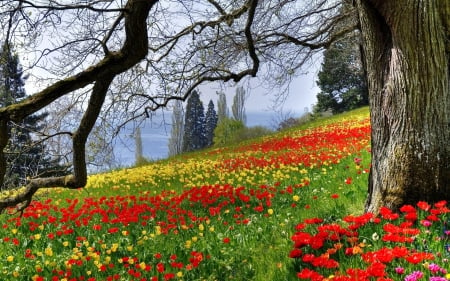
356, 0, 450, 213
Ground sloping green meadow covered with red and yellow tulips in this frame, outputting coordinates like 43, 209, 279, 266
0, 108, 450, 281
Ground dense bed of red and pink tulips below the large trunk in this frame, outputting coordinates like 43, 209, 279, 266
289, 201, 450, 281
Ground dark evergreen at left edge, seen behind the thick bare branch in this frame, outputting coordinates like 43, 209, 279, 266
0, 44, 64, 188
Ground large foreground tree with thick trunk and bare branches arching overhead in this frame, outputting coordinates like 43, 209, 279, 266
0, 0, 450, 212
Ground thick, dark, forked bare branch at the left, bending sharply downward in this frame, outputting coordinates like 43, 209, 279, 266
0, 0, 157, 210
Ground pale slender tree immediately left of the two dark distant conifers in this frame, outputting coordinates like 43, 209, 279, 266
169, 101, 184, 156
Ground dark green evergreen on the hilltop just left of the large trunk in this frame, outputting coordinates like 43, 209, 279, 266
315, 33, 369, 114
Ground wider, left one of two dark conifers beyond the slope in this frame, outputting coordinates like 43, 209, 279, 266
183, 91, 206, 152
